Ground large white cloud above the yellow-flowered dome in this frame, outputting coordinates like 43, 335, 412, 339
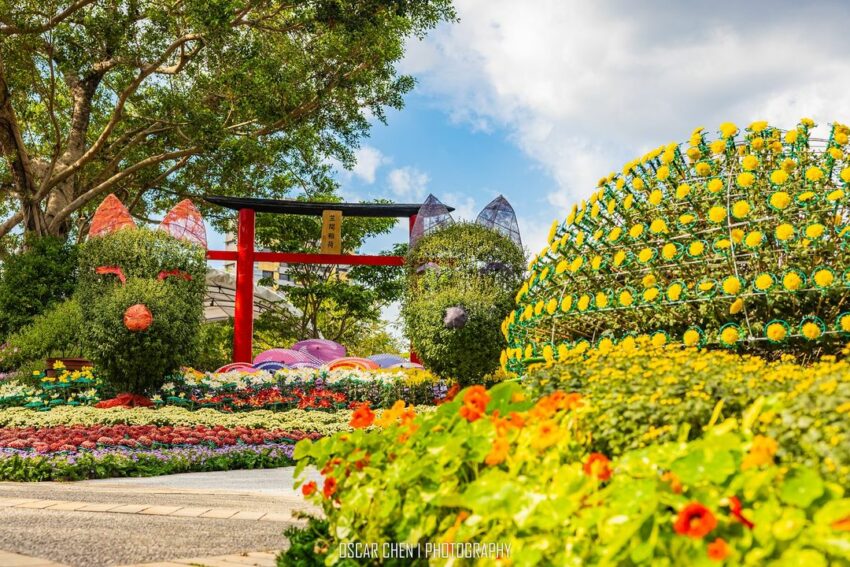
404, 0, 850, 221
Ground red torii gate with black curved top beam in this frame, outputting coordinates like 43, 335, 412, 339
204, 195, 454, 362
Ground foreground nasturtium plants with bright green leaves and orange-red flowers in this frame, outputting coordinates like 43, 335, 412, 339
295, 382, 850, 567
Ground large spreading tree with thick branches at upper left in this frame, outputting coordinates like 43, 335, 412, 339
0, 0, 454, 244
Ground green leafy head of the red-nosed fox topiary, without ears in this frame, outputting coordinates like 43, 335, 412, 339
77, 229, 206, 393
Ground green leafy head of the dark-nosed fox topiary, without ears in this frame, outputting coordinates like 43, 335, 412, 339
401, 223, 525, 384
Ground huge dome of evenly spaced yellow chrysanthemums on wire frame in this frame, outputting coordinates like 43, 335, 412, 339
503, 119, 850, 372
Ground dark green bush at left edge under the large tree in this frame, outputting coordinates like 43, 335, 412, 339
0, 237, 77, 341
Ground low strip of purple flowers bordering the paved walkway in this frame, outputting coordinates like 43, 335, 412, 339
0, 443, 293, 481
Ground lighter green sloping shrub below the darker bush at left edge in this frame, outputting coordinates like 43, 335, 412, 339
0, 299, 84, 377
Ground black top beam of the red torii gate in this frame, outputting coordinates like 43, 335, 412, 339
204, 195, 454, 218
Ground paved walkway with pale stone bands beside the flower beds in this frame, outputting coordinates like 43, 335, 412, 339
0, 467, 317, 567
